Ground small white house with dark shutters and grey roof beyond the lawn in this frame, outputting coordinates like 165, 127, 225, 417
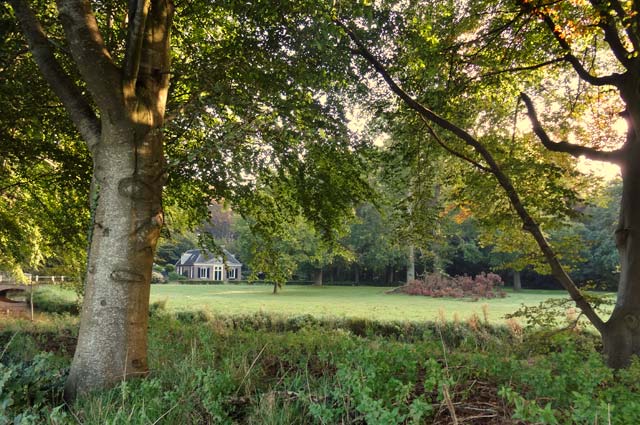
176, 249, 242, 281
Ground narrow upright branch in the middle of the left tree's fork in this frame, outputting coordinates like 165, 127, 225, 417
123, 0, 151, 94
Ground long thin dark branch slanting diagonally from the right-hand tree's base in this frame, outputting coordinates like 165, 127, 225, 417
335, 19, 606, 332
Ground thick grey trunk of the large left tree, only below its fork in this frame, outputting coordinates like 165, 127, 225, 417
66, 123, 164, 398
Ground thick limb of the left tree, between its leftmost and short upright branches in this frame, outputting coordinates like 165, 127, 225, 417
58, 0, 123, 116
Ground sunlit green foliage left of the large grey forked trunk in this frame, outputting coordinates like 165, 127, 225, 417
0, 2, 91, 276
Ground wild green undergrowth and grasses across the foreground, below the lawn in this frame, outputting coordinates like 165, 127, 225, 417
0, 304, 640, 425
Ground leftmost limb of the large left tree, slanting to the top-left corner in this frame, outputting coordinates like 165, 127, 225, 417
11, 0, 100, 148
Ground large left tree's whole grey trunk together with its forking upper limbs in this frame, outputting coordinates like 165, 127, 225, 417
11, 0, 174, 400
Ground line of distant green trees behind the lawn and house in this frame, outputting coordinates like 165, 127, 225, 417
156, 180, 621, 290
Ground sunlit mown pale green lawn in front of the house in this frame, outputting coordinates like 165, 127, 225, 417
151, 284, 592, 322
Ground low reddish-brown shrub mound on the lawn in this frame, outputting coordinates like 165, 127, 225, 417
392, 273, 506, 300
